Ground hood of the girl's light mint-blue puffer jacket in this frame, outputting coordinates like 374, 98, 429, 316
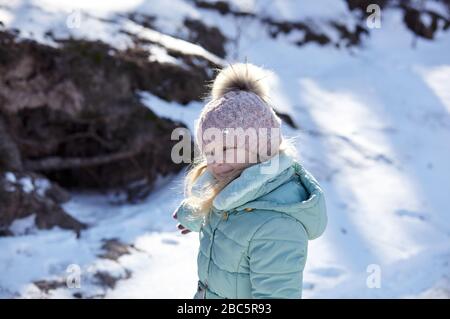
193, 152, 327, 239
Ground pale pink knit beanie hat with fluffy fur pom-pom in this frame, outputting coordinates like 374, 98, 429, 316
196, 63, 282, 162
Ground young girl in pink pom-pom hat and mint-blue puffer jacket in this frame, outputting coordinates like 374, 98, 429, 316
173, 63, 327, 298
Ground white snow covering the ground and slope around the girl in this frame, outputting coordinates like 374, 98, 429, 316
0, 0, 450, 298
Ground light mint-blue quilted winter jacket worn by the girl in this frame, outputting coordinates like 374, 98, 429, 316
177, 153, 327, 298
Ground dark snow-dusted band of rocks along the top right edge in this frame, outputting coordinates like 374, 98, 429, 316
192, 0, 450, 48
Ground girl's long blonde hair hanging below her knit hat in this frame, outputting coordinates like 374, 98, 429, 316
184, 138, 297, 219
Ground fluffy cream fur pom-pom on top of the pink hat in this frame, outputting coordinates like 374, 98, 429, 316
211, 63, 268, 100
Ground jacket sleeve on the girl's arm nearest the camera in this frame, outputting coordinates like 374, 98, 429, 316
248, 216, 308, 299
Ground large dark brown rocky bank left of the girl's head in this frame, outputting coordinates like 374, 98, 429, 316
0, 31, 212, 195
